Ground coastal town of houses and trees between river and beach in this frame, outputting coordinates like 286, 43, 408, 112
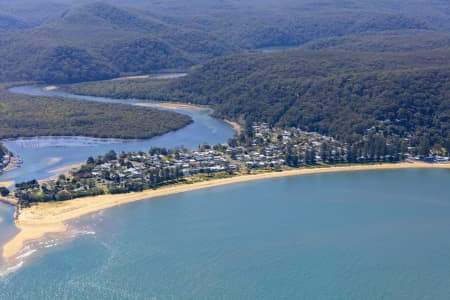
10, 123, 449, 206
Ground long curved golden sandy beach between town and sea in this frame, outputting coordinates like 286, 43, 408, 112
3, 162, 450, 259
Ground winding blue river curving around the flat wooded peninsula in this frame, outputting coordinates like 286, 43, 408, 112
0, 86, 235, 182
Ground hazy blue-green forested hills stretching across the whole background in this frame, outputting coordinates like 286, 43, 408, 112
0, 0, 450, 83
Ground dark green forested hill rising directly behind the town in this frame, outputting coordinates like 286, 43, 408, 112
65, 49, 450, 153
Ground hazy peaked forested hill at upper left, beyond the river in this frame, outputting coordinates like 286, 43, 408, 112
0, 3, 232, 83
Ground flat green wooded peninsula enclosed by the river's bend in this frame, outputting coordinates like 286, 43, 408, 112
0, 85, 192, 139
